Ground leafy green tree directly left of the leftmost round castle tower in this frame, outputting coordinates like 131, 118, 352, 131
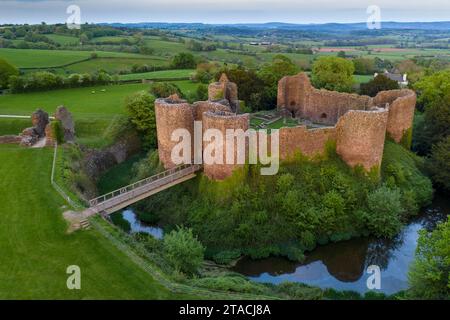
125, 91, 157, 148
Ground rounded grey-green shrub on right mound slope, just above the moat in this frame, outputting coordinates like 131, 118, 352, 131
363, 186, 403, 238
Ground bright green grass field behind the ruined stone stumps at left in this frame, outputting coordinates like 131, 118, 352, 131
0, 80, 198, 147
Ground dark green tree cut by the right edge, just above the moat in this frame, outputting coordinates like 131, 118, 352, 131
428, 135, 450, 191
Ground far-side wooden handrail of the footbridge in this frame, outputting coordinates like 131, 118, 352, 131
89, 164, 201, 207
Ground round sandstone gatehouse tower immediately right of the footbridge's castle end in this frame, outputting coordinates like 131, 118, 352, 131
203, 111, 249, 180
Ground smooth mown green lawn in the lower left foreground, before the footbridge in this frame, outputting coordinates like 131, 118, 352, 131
0, 145, 190, 299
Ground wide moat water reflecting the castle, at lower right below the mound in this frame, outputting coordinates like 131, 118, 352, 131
230, 197, 450, 294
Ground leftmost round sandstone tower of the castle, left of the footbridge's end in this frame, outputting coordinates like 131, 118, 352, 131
155, 97, 194, 169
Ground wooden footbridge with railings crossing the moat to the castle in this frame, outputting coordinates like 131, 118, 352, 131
83, 164, 202, 218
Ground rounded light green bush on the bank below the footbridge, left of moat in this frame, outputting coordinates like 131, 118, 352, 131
163, 227, 205, 274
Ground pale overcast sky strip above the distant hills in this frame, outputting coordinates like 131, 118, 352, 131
0, 0, 450, 24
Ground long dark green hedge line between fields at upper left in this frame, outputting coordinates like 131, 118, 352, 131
8, 71, 118, 93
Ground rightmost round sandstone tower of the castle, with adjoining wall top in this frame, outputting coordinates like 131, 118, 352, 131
374, 89, 417, 143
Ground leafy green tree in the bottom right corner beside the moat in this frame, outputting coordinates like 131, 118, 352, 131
408, 219, 450, 299
